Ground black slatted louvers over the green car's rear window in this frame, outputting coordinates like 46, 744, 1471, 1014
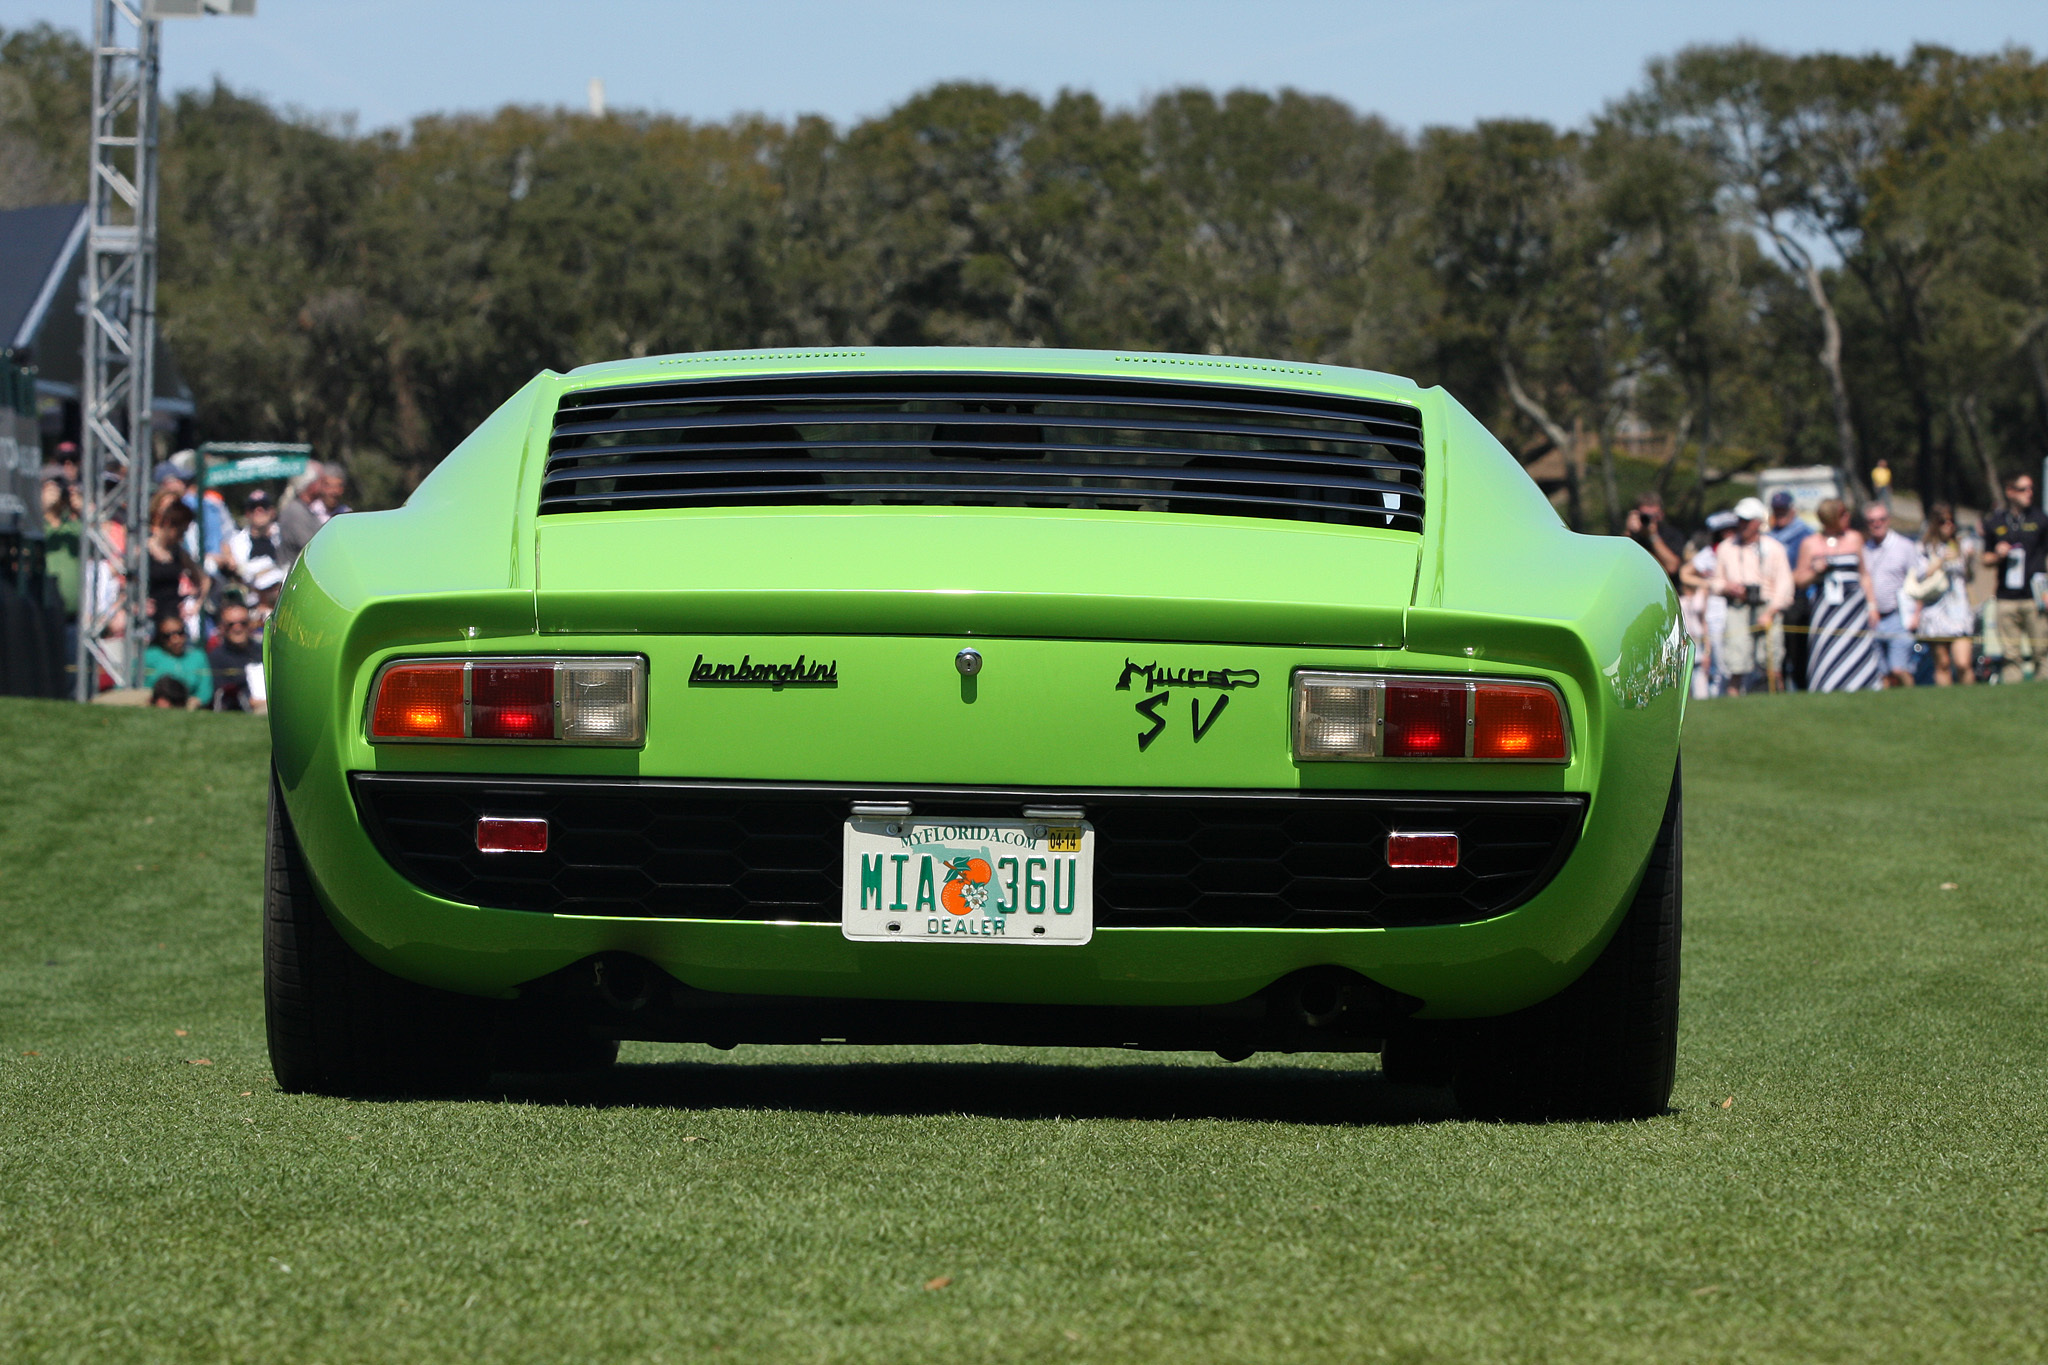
541, 375, 1423, 530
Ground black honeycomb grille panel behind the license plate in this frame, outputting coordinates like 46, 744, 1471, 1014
354, 774, 1585, 929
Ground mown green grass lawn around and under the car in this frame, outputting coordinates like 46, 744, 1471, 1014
0, 688, 2048, 1365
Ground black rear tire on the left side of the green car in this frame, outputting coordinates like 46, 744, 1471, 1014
262, 778, 492, 1095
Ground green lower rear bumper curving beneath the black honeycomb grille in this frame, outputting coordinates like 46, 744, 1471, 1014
287, 776, 1669, 1036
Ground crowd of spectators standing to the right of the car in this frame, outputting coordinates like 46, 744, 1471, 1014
1624, 475, 2048, 698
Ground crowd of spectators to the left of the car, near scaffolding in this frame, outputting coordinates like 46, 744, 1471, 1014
43, 444, 348, 710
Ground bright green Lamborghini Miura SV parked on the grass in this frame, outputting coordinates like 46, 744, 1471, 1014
264, 348, 1688, 1117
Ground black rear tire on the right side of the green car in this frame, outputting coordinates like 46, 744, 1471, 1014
1454, 757, 1686, 1121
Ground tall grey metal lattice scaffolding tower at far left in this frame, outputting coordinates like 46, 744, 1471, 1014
78, 0, 158, 702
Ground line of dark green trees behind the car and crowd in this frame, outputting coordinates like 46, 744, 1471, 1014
0, 27, 2048, 530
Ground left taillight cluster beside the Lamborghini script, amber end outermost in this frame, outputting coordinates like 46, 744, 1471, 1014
371, 659, 647, 745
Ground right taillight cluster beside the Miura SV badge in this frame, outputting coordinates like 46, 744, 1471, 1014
1294, 669, 1571, 763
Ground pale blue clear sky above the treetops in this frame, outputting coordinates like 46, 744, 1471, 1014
0, 0, 2048, 129
